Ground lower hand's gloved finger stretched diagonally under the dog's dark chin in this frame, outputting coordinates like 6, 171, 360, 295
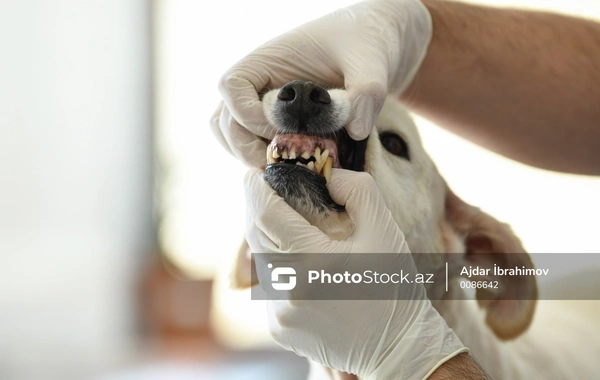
244, 170, 332, 253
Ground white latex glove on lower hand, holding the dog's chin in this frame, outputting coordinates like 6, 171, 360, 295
245, 169, 468, 379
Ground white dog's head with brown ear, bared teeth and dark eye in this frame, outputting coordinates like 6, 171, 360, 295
240, 81, 537, 339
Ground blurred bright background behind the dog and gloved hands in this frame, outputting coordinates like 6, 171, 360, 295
0, 0, 600, 379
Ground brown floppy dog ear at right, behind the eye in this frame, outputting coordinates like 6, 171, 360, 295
445, 187, 537, 340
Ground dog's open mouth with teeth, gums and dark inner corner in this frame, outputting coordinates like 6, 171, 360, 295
267, 129, 367, 183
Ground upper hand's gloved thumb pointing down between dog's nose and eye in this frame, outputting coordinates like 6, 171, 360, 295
345, 75, 387, 141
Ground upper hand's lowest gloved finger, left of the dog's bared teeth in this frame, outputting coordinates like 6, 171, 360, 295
217, 102, 267, 168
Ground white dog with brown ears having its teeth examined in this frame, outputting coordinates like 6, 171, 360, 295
234, 81, 600, 379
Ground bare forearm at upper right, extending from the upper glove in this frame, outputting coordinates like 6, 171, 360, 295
402, 0, 600, 174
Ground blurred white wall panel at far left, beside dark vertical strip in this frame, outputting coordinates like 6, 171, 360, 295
0, 0, 152, 379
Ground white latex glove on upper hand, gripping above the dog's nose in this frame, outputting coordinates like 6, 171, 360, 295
211, 0, 432, 167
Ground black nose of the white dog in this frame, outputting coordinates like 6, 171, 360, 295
277, 80, 331, 130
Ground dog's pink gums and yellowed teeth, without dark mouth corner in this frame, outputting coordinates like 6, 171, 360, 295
267, 134, 340, 183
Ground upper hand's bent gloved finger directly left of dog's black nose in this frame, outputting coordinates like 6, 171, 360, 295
219, 69, 275, 140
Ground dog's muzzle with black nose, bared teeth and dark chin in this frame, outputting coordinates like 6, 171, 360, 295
265, 81, 367, 217
